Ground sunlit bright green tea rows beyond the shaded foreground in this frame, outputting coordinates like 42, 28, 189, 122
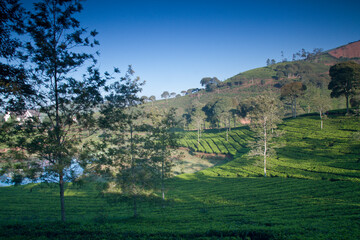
181, 115, 360, 182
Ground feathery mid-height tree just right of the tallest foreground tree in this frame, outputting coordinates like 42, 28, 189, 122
83, 66, 148, 217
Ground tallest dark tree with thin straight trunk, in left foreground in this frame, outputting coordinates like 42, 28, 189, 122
3, 0, 105, 221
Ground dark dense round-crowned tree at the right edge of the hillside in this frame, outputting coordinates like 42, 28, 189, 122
328, 61, 360, 113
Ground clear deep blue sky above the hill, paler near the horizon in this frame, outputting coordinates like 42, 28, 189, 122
58, 0, 360, 99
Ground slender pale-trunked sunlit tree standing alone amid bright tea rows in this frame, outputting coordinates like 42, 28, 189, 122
249, 93, 282, 177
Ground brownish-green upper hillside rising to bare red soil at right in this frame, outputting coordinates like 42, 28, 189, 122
149, 41, 360, 120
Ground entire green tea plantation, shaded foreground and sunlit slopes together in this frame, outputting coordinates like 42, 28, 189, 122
0, 114, 360, 239
